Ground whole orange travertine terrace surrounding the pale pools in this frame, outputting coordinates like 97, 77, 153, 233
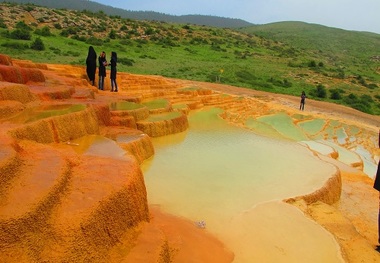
0, 55, 378, 262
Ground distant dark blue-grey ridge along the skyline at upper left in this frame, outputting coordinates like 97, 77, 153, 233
2, 0, 252, 28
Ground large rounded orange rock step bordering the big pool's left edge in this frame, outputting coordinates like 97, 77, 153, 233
41, 155, 149, 262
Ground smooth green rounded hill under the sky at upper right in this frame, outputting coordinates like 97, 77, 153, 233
242, 21, 380, 65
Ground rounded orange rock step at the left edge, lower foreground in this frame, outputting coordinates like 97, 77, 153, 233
0, 142, 70, 248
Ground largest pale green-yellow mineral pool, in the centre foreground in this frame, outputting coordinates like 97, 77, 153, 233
142, 109, 343, 262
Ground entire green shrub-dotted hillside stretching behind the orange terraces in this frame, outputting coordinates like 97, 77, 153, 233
0, 3, 380, 114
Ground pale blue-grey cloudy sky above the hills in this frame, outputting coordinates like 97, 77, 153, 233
93, 0, 380, 34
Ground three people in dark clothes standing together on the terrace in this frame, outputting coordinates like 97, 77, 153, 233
86, 46, 118, 92
